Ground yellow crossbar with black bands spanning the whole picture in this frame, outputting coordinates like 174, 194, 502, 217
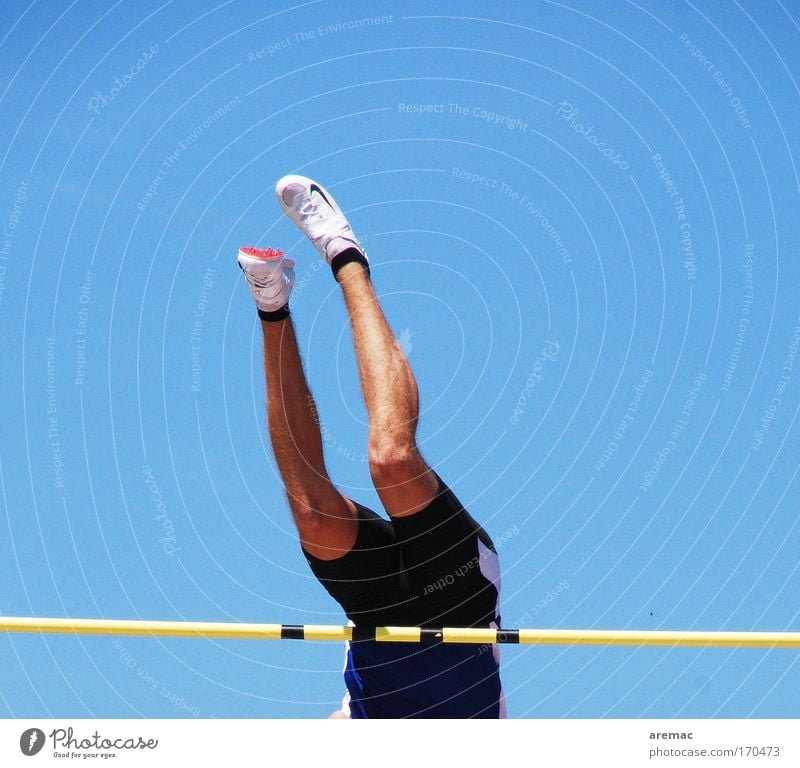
0, 616, 800, 648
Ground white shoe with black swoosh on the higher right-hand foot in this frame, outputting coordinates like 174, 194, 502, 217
275, 176, 368, 264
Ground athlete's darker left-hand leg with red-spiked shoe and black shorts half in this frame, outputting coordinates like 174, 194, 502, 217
239, 248, 413, 626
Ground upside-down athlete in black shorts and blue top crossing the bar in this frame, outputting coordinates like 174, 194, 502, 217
238, 176, 504, 718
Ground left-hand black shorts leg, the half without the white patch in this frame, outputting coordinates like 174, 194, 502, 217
303, 503, 416, 626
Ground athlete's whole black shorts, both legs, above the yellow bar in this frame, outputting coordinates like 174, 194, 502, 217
305, 476, 500, 627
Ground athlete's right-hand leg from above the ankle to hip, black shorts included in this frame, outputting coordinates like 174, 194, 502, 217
336, 262, 500, 626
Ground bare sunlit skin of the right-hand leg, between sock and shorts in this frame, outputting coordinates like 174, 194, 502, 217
337, 263, 438, 517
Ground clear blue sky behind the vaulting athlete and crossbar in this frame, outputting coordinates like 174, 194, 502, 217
0, 0, 800, 717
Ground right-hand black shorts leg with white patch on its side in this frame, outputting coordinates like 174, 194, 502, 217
392, 475, 500, 627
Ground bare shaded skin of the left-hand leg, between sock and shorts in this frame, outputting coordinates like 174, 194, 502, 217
261, 318, 358, 560
